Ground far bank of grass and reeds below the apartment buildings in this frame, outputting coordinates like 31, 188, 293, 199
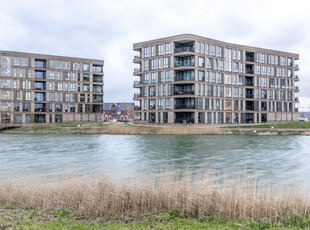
1, 122, 310, 135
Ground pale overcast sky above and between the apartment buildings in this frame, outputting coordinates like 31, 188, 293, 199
0, 0, 310, 111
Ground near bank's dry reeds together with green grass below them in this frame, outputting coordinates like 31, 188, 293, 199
0, 173, 310, 229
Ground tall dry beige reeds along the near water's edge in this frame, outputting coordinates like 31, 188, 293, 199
0, 173, 310, 221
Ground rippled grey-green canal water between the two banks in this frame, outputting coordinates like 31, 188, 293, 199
0, 134, 310, 187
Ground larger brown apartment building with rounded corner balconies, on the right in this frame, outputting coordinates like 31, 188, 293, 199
133, 34, 299, 125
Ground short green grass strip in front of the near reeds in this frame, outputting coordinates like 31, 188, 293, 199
0, 207, 310, 229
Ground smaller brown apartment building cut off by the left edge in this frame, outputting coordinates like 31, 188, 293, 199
0, 51, 104, 123
